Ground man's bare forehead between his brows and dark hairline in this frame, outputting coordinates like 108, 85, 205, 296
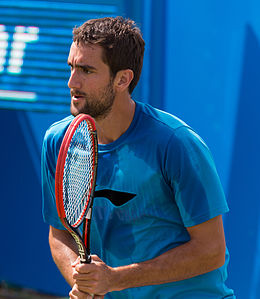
68, 42, 104, 64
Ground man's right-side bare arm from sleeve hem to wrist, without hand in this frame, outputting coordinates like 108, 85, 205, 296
110, 216, 226, 290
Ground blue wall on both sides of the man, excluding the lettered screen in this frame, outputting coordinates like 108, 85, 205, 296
0, 0, 260, 299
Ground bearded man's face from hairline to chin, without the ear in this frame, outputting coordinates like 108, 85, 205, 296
68, 43, 115, 120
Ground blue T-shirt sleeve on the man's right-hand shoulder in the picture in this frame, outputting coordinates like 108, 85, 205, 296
165, 126, 228, 227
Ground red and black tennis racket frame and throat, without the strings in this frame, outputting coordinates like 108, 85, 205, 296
55, 113, 98, 263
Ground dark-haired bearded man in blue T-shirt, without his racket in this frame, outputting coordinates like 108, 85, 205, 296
42, 17, 235, 299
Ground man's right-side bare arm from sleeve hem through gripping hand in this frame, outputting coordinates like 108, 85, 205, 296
73, 216, 226, 294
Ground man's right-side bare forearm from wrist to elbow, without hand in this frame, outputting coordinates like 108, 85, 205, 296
113, 242, 224, 291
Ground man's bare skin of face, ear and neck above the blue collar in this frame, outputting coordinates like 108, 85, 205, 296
68, 43, 135, 143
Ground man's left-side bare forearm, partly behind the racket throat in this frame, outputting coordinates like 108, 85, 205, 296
49, 227, 77, 287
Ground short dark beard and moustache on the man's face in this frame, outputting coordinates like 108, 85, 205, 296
70, 80, 115, 120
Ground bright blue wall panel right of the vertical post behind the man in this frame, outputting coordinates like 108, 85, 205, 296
162, 0, 260, 299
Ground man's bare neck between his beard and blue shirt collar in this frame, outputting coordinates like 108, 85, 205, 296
96, 95, 135, 144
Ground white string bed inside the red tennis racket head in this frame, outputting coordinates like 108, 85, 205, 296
63, 121, 95, 227
